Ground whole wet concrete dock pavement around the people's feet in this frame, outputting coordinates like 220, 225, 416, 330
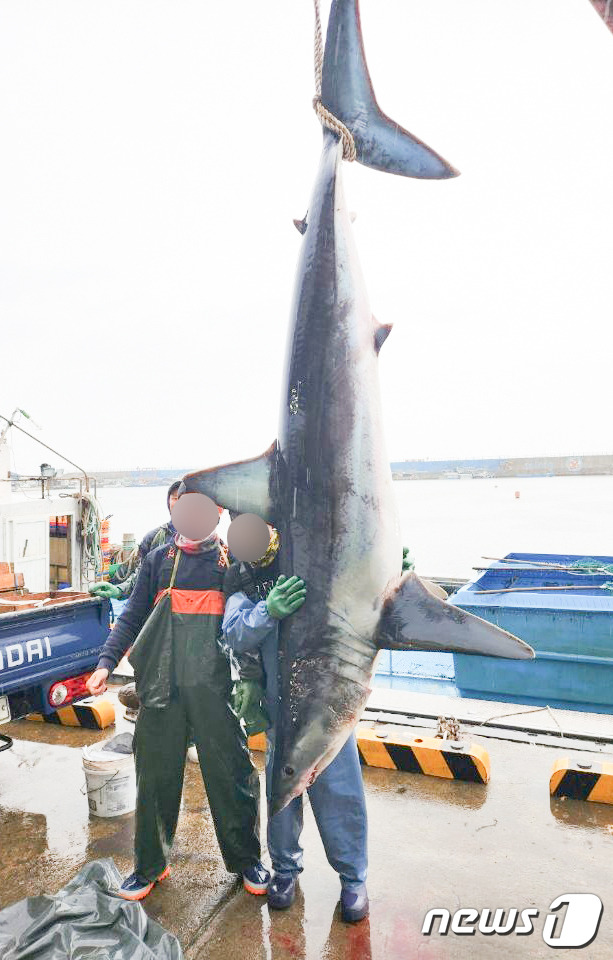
0, 692, 613, 960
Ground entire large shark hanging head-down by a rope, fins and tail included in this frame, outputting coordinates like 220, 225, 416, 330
182, 0, 534, 813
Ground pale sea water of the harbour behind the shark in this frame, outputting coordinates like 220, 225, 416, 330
98, 476, 613, 579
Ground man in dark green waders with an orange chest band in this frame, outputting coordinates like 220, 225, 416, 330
88, 494, 270, 900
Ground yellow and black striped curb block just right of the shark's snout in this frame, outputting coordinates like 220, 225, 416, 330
358, 725, 490, 783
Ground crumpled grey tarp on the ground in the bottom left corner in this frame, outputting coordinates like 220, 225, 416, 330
0, 859, 183, 960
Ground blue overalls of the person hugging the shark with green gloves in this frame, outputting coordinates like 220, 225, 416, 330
222, 592, 368, 892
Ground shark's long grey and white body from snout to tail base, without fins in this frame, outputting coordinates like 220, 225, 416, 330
273, 135, 402, 801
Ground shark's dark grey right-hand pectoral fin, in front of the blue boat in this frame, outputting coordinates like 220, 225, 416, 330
375, 573, 534, 660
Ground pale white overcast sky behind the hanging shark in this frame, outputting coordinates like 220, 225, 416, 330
0, 0, 613, 472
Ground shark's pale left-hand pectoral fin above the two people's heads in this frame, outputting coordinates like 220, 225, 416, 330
179, 440, 278, 523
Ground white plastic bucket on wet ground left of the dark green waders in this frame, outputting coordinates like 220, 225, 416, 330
83, 744, 136, 817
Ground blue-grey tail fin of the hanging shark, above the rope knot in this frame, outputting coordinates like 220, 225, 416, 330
321, 0, 458, 180
